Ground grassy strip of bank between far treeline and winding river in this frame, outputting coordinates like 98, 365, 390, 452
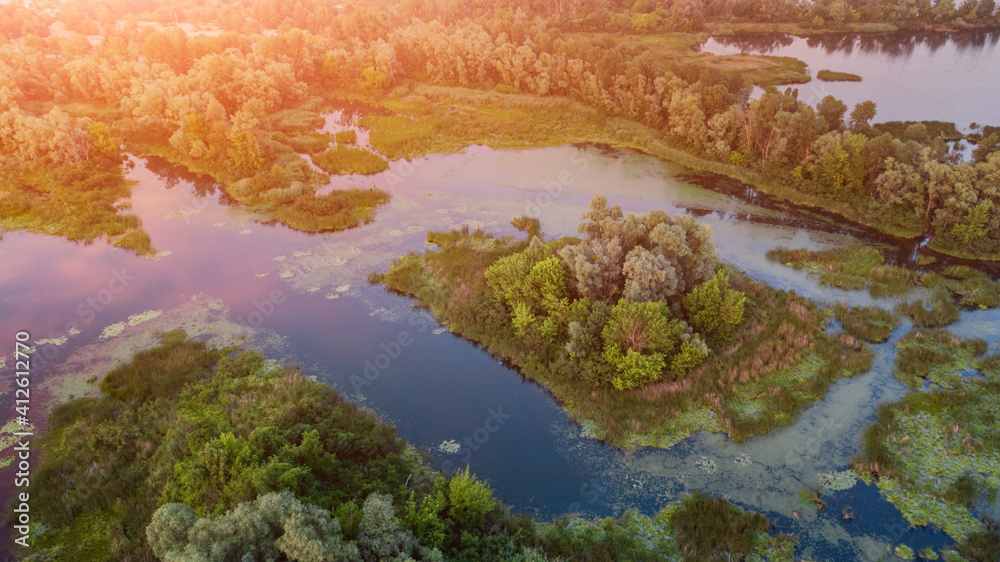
361, 84, 948, 250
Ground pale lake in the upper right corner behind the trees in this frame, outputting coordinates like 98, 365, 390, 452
701, 30, 1000, 132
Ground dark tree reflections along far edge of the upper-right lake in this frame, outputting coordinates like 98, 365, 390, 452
715, 29, 1000, 59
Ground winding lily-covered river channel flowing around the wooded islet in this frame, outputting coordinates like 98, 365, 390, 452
0, 141, 1000, 559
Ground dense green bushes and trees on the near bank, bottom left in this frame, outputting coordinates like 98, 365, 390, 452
19, 332, 796, 562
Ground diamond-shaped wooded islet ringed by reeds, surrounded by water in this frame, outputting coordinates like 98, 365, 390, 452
372, 196, 871, 447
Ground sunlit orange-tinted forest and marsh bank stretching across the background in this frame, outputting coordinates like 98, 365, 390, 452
0, 0, 1000, 259
